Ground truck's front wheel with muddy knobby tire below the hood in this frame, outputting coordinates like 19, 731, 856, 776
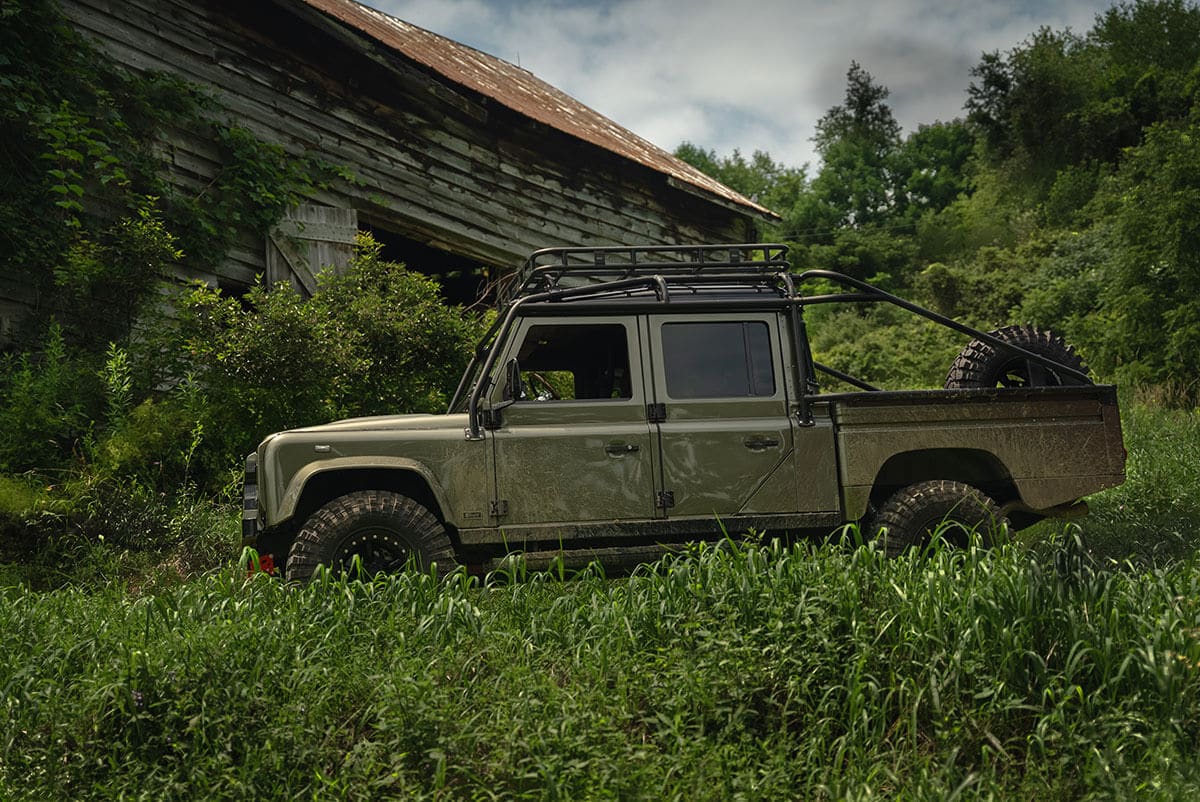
287, 490, 456, 582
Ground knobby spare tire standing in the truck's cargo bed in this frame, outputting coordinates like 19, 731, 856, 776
946, 325, 1091, 390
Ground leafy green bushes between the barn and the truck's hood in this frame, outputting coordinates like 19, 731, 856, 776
0, 231, 480, 585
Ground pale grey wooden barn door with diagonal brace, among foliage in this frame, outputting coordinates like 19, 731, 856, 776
266, 204, 359, 298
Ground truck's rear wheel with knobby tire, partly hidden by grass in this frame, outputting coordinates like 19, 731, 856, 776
870, 479, 1007, 557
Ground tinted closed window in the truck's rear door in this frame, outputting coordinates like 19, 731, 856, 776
662, 321, 775, 399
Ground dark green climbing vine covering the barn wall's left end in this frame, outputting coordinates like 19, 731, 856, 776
0, 0, 352, 352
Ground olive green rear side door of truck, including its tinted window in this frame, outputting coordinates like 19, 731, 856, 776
648, 312, 800, 519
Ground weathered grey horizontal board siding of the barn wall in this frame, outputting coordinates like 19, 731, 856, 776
62, 0, 750, 283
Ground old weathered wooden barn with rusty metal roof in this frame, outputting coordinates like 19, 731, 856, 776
61, 0, 773, 299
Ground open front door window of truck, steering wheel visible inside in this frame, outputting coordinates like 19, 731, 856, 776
517, 323, 634, 401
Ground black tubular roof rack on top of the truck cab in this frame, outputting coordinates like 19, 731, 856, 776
499, 243, 791, 305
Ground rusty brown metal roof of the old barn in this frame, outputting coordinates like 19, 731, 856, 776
301, 0, 778, 219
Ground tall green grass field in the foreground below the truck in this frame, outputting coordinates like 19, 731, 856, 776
0, 407, 1200, 800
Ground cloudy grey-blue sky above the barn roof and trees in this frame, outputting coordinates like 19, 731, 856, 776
365, 0, 1115, 170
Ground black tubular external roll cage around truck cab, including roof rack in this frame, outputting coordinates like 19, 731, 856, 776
448, 243, 1091, 439
